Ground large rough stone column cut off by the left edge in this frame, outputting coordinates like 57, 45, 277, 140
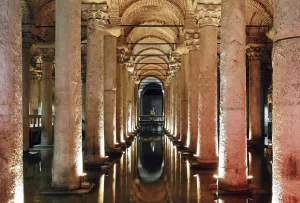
0, 0, 24, 203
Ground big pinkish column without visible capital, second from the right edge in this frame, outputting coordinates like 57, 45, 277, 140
219, 0, 248, 191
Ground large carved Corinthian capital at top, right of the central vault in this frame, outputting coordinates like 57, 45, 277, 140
194, 0, 221, 27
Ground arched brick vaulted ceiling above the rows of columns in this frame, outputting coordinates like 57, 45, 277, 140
23, 0, 274, 80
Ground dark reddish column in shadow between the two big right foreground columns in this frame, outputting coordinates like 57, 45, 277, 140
247, 47, 263, 144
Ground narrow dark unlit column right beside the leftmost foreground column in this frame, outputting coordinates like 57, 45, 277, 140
22, 29, 31, 152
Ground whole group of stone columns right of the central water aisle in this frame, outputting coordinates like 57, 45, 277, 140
166, 0, 300, 197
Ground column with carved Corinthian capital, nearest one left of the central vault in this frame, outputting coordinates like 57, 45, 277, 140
84, 4, 109, 164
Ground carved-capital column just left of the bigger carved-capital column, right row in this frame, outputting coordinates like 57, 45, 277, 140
185, 30, 201, 152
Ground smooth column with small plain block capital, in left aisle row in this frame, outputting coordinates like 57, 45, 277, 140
104, 28, 120, 148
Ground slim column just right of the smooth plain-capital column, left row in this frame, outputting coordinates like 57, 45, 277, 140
116, 53, 124, 143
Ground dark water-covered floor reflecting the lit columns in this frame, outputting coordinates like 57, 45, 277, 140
24, 132, 271, 203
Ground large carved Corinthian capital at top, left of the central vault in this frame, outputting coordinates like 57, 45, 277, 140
81, 2, 109, 27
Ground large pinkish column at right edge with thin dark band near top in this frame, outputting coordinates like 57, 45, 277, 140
272, 0, 300, 203
